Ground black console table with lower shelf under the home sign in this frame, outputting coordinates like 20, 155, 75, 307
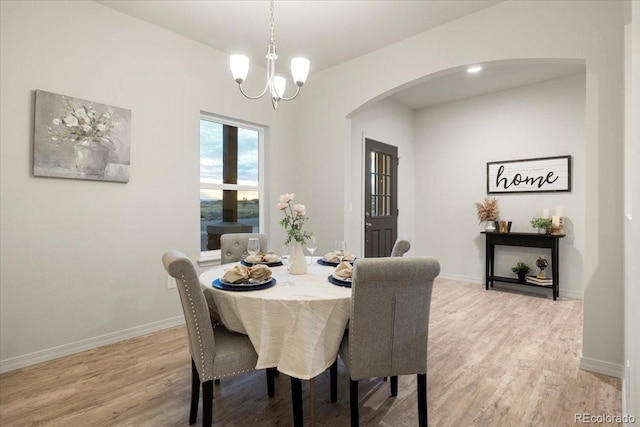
481, 231, 565, 301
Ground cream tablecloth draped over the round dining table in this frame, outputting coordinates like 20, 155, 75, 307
200, 258, 351, 380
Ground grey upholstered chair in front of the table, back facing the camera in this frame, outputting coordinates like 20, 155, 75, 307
331, 257, 440, 427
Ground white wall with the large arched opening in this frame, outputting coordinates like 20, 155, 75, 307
297, 1, 624, 376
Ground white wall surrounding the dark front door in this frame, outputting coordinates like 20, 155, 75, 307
345, 98, 416, 255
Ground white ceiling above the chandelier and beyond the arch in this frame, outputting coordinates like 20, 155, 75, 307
94, 0, 584, 109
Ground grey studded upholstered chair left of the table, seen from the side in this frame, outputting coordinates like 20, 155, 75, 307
162, 250, 275, 427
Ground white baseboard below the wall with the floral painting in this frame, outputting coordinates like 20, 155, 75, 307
0, 316, 184, 373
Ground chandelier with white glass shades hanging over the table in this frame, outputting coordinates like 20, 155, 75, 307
229, 0, 309, 110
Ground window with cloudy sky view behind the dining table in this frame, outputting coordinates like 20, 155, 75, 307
200, 116, 263, 252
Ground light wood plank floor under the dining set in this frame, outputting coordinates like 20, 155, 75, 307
0, 279, 621, 427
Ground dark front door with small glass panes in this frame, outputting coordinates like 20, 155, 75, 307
364, 138, 398, 258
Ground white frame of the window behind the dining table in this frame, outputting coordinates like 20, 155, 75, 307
198, 111, 266, 266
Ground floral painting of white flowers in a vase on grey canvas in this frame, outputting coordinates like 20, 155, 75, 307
33, 90, 131, 182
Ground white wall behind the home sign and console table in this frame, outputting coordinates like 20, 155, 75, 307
415, 74, 586, 298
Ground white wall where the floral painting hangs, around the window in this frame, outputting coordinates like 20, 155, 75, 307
0, 1, 295, 370
